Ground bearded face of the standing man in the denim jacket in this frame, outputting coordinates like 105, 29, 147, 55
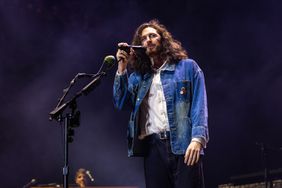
141, 27, 161, 57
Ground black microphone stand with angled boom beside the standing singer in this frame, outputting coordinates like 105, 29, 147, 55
49, 69, 106, 188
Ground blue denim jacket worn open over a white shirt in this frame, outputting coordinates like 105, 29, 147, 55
113, 59, 209, 156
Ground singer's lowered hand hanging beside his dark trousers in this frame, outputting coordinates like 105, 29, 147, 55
184, 141, 202, 166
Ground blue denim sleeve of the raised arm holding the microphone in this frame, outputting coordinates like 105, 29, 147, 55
113, 72, 138, 110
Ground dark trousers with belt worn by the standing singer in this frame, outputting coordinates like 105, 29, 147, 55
144, 134, 204, 188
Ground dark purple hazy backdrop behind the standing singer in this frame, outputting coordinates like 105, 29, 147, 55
0, 0, 282, 188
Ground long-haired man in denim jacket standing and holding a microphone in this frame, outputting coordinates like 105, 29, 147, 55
113, 20, 209, 188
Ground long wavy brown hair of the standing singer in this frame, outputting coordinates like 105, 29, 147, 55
130, 19, 188, 74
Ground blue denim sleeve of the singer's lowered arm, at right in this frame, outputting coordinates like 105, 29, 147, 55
191, 62, 209, 147
